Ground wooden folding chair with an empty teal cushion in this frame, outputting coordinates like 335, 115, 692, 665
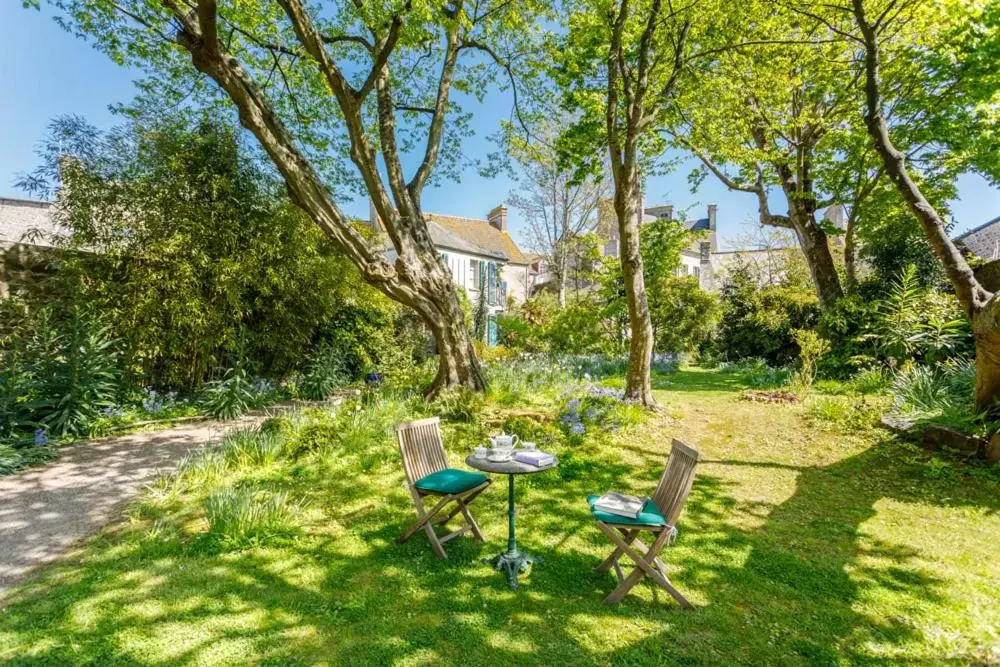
396, 417, 493, 558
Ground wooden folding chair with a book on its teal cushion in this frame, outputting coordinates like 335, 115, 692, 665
587, 440, 698, 609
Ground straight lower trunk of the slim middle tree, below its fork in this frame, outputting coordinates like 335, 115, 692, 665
615, 171, 656, 408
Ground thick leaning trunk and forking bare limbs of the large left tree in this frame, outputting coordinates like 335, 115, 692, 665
175, 9, 486, 397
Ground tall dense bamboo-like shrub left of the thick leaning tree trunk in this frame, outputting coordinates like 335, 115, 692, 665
19, 115, 398, 390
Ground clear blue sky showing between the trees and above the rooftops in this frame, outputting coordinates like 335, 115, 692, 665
0, 0, 1000, 250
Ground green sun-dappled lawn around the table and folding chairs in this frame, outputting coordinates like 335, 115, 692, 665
0, 369, 1000, 666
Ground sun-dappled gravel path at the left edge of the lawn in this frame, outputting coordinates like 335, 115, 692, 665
0, 417, 260, 597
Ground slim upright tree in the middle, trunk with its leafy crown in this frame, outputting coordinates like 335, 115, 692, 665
554, 0, 710, 407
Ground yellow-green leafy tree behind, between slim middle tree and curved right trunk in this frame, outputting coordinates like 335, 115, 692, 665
665, 2, 856, 307
